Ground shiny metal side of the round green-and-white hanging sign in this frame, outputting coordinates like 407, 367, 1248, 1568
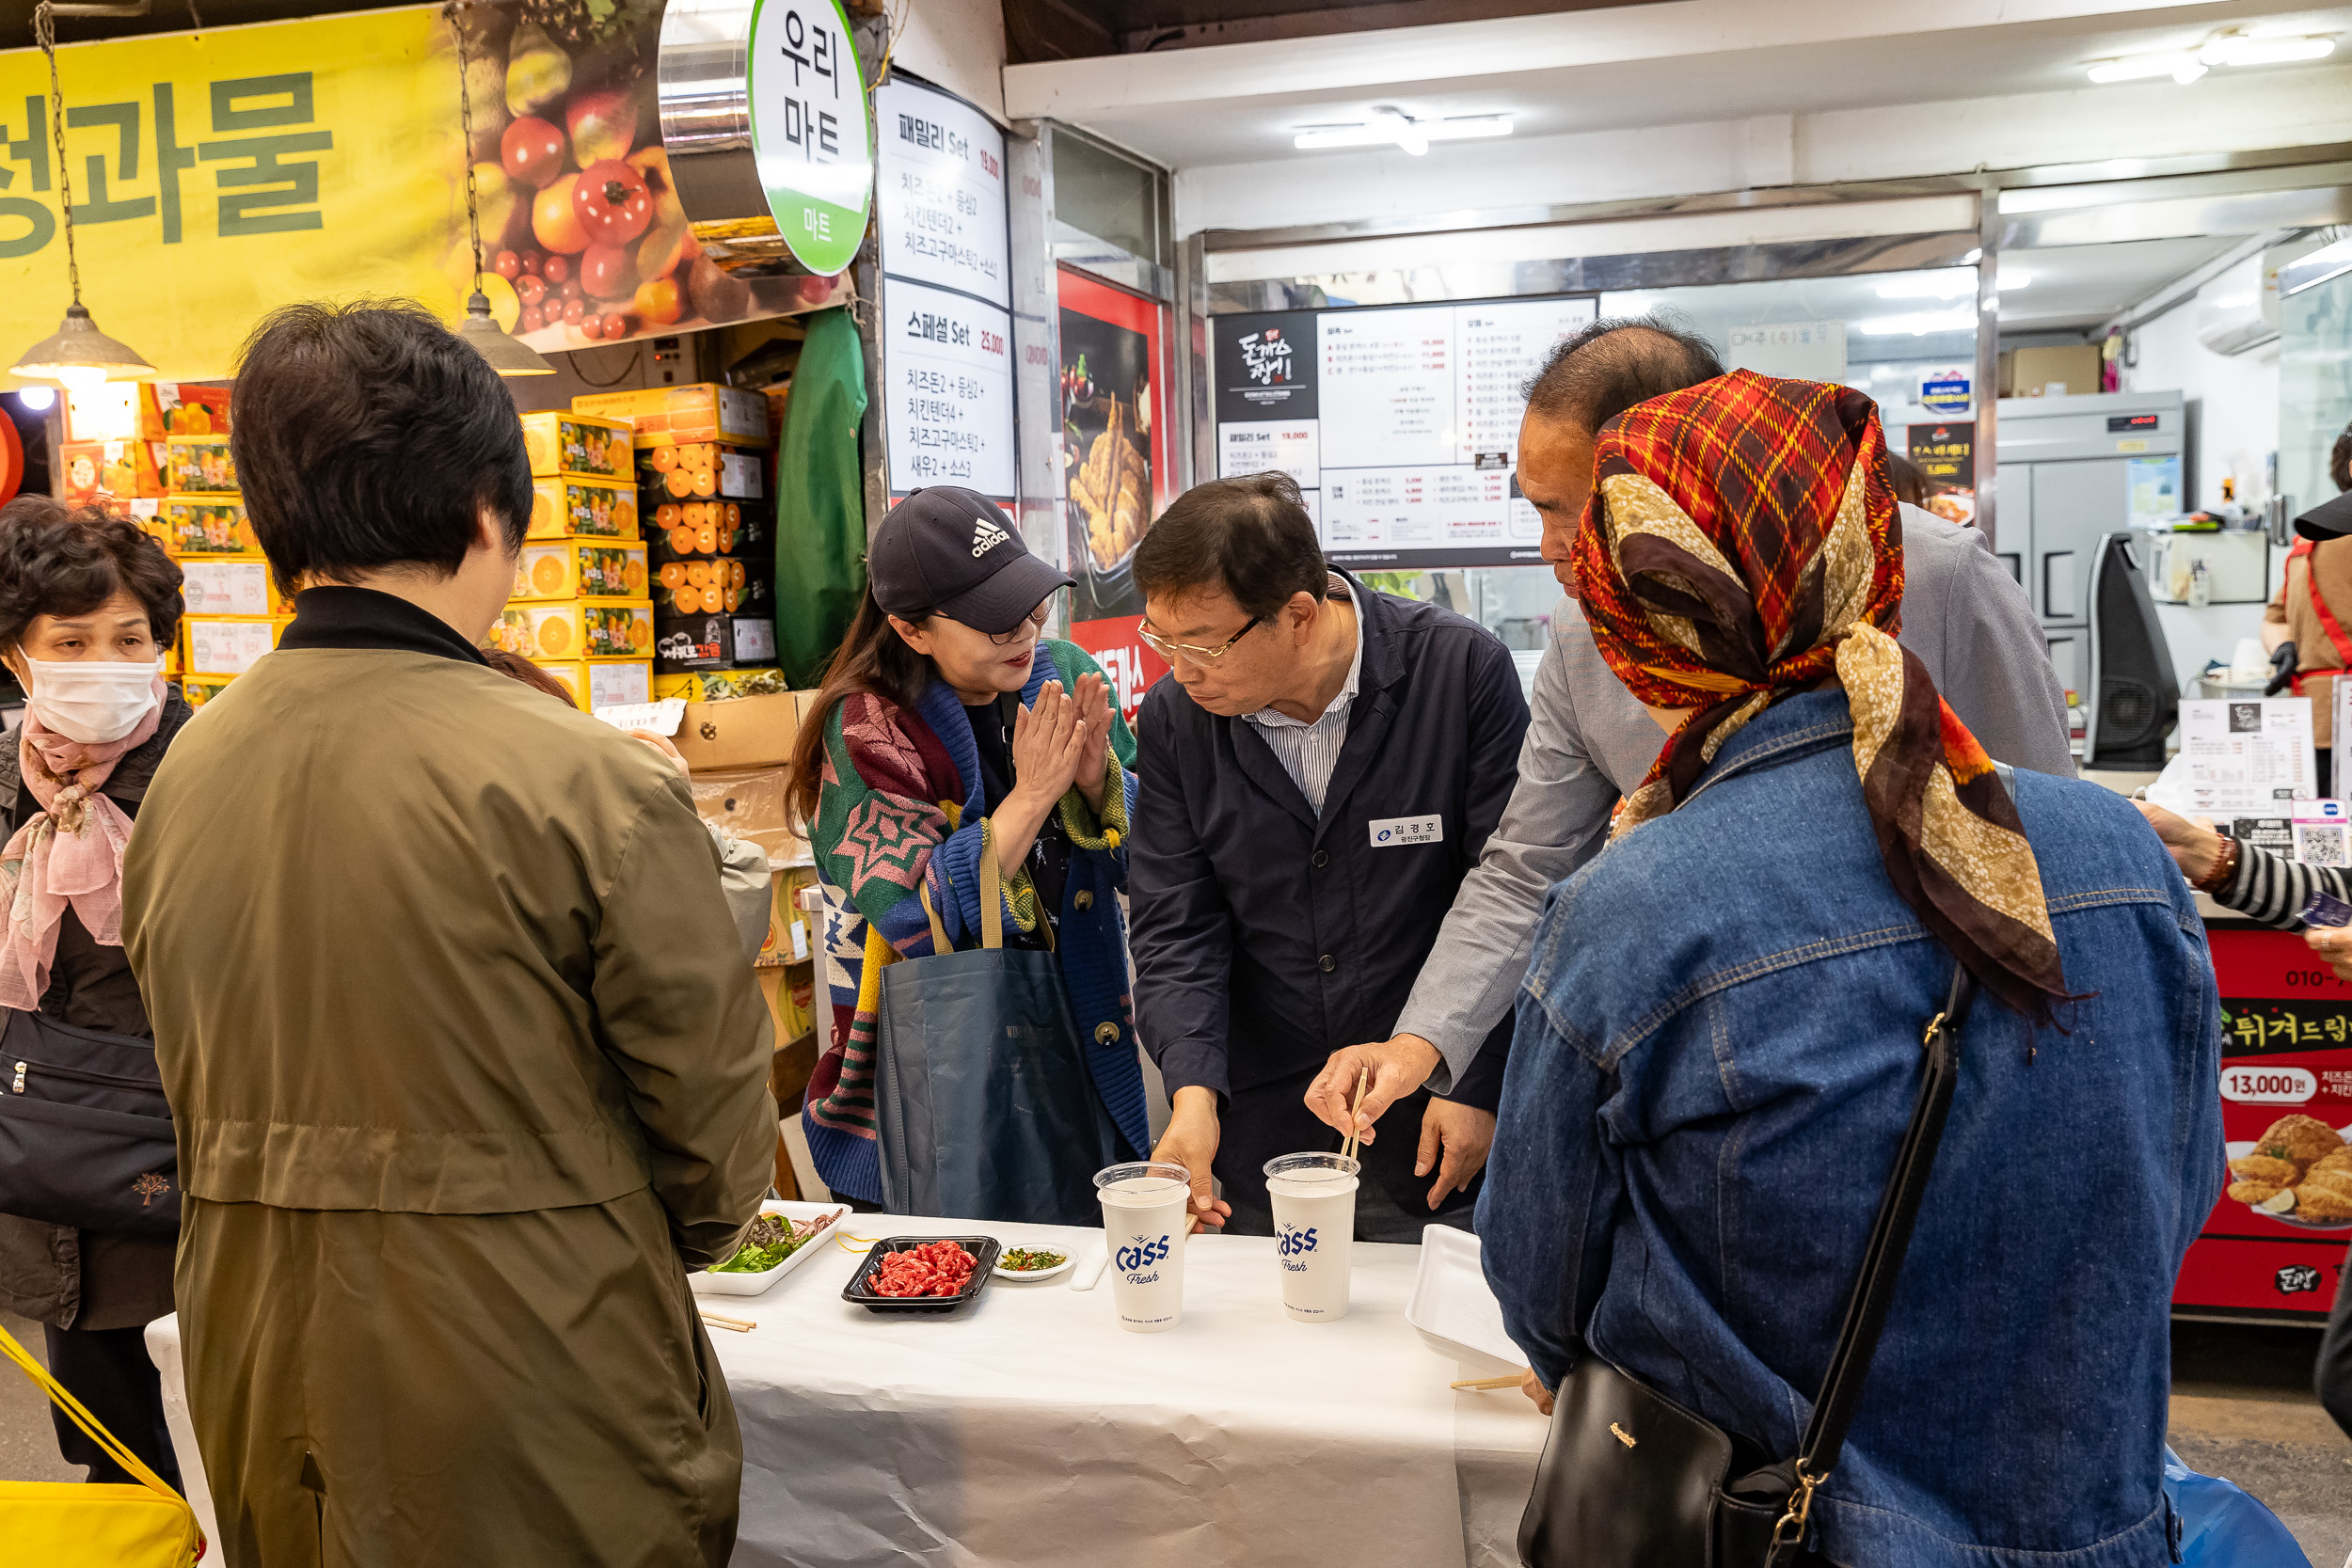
659, 0, 809, 277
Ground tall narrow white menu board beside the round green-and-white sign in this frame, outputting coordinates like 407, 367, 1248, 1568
875, 75, 1016, 500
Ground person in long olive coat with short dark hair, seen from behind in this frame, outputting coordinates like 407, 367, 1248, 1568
122, 306, 776, 1568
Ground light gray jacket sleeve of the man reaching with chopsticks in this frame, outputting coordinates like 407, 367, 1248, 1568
1397, 602, 1628, 1093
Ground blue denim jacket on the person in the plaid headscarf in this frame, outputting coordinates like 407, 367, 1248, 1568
1477, 691, 2223, 1568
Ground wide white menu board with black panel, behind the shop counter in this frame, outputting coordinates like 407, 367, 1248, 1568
1212, 293, 1595, 569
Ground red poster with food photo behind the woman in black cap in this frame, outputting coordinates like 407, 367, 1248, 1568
1058, 268, 1171, 720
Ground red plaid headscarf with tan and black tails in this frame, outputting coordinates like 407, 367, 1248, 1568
1576, 372, 2068, 1016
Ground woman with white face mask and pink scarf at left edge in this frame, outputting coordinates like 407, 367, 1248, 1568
0, 496, 191, 1486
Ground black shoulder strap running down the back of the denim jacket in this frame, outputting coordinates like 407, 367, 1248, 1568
1769, 964, 1976, 1566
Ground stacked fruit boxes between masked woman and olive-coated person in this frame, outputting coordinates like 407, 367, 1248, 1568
149, 430, 294, 707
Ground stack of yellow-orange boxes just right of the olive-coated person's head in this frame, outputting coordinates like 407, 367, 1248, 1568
483, 409, 654, 707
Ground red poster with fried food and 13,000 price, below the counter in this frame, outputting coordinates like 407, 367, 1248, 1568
2173, 927, 2352, 1322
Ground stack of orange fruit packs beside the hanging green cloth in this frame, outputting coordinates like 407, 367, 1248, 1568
572, 383, 776, 677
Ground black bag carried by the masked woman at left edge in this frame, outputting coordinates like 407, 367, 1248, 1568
0, 1011, 179, 1237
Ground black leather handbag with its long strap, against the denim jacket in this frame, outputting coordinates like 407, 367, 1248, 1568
1519, 966, 1976, 1568
